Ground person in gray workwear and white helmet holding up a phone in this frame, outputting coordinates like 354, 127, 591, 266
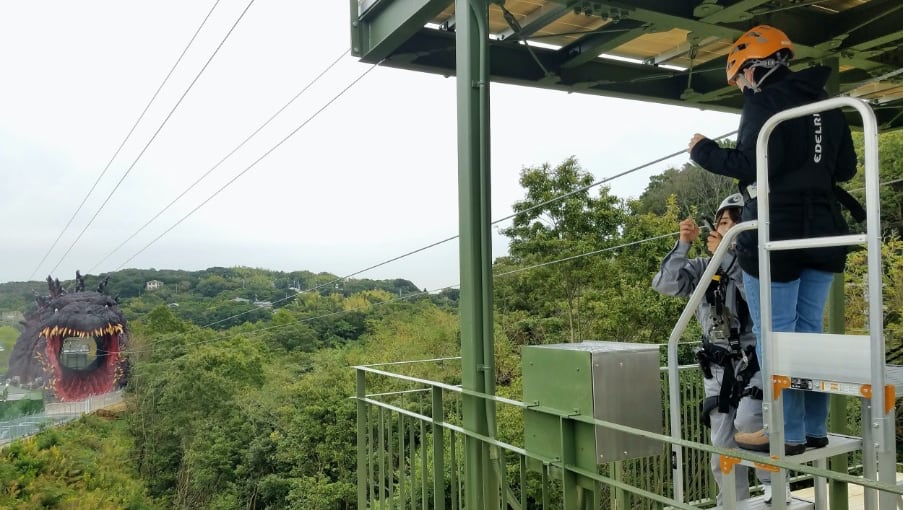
653, 193, 769, 505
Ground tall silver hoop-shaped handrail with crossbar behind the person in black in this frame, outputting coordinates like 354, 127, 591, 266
756, 97, 894, 508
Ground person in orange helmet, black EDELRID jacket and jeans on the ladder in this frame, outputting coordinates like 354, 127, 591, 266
688, 25, 857, 455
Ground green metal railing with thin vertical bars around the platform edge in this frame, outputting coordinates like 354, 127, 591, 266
354, 358, 901, 510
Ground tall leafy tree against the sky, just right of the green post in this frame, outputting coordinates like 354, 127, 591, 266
496, 156, 625, 341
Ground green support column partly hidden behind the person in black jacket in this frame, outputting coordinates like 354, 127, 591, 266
823, 58, 848, 510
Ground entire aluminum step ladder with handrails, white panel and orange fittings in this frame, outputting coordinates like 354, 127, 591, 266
668, 98, 902, 510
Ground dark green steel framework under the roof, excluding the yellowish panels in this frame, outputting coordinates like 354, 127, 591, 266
350, 0, 902, 128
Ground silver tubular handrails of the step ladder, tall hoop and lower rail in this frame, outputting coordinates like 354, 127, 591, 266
667, 97, 894, 508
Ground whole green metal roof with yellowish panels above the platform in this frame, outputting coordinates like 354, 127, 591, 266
350, 0, 902, 129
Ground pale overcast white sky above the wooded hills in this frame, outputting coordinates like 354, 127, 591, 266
0, 0, 738, 290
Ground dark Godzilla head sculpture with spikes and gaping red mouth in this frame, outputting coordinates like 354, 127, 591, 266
7, 272, 129, 402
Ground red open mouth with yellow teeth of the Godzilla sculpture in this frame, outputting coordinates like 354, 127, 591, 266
41, 323, 123, 401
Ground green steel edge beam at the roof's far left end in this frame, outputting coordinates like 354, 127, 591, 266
350, 0, 449, 63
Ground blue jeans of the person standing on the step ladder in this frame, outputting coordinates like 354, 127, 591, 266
744, 269, 834, 444
